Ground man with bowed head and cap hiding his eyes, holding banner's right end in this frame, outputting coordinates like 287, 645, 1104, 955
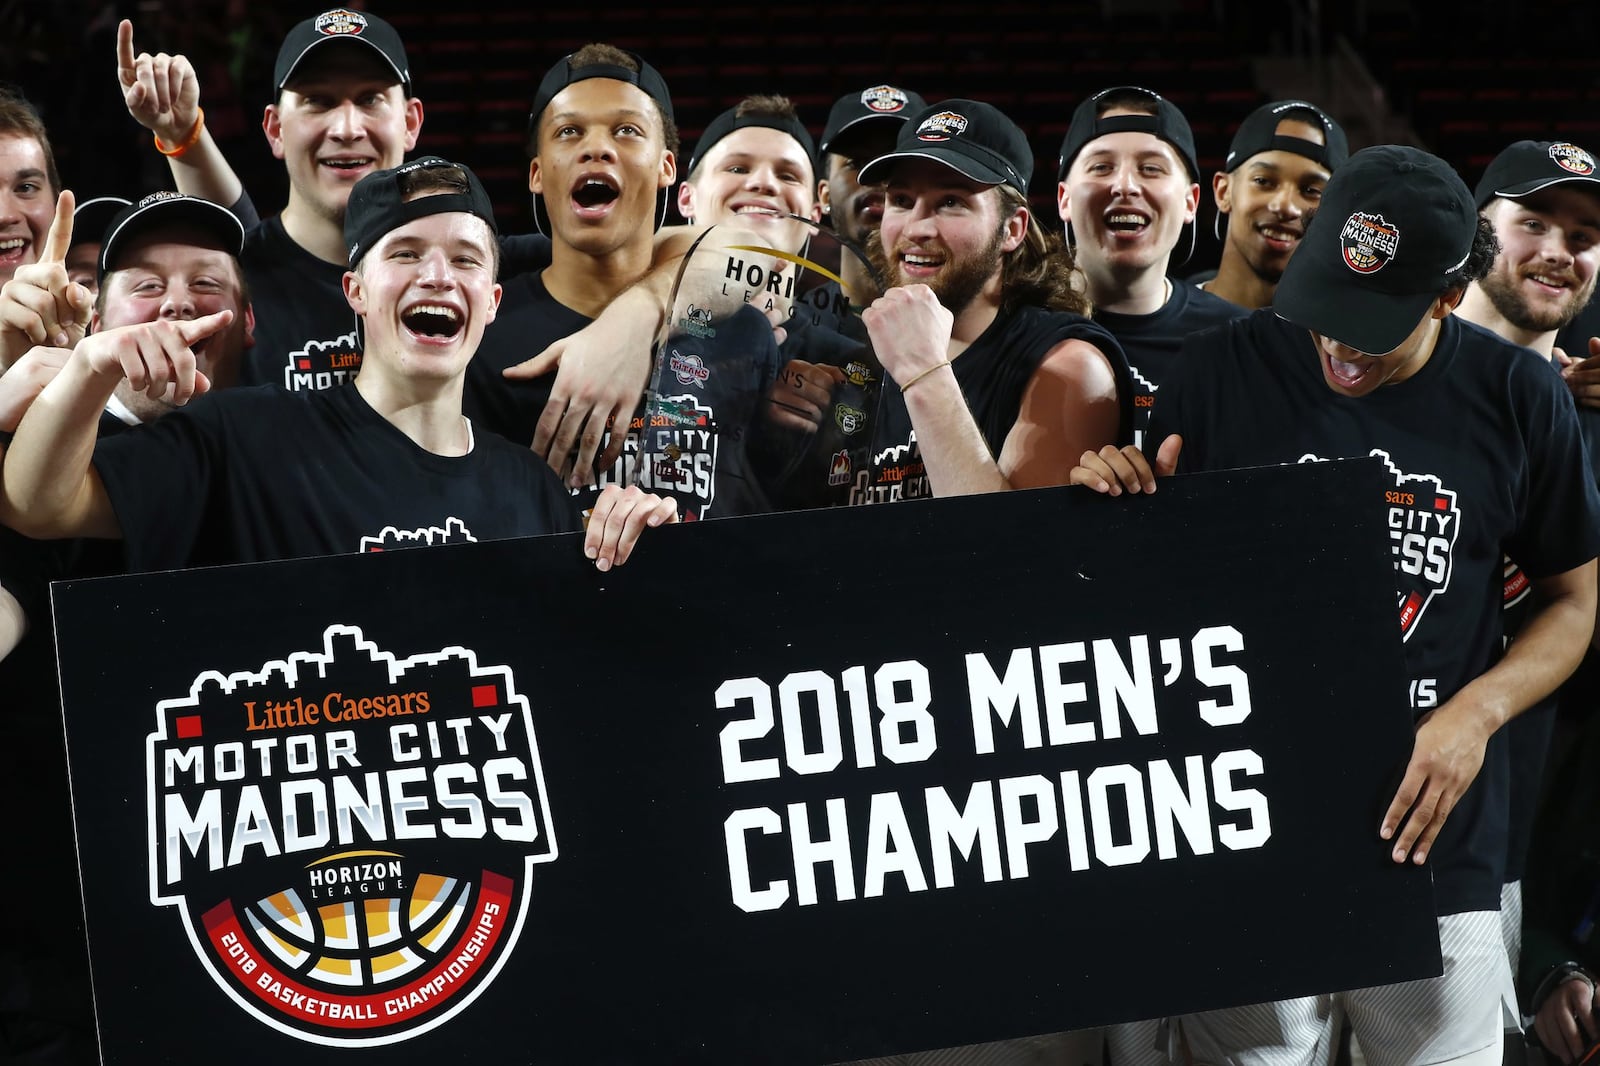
1072, 146, 1600, 1066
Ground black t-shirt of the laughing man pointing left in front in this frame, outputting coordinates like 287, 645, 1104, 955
94, 377, 579, 571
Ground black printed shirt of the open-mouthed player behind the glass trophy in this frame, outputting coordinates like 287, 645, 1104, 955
462, 272, 779, 522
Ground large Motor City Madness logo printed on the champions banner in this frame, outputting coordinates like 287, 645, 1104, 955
146, 626, 555, 1045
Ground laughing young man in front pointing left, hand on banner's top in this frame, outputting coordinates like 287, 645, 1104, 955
0, 157, 675, 570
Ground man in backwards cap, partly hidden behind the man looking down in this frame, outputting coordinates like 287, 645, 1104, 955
1190, 99, 1350, 311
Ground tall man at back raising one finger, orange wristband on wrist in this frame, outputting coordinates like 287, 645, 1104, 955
117, 8, 422, 391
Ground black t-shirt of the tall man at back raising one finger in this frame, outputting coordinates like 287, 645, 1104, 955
235, 205, 550, 392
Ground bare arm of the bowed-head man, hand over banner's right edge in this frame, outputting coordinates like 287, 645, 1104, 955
1379, 559, 1595, 864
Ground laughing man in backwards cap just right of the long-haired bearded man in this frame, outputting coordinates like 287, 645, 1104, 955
1056, 85, 1245, 443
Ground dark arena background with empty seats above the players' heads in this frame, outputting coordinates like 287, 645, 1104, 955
9, 0, 1600, 274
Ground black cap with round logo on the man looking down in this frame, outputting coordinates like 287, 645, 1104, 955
1272, 144, 1478, 355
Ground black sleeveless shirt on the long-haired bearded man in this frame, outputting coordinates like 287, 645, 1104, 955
850, 307, 1133, 504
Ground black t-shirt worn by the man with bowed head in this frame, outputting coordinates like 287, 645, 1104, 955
1150, 309, 1600, 914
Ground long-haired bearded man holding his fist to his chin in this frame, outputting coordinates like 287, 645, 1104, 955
850, 99, 1133, 504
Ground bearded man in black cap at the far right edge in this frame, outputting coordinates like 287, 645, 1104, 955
1456, 132, 1600, 1029
